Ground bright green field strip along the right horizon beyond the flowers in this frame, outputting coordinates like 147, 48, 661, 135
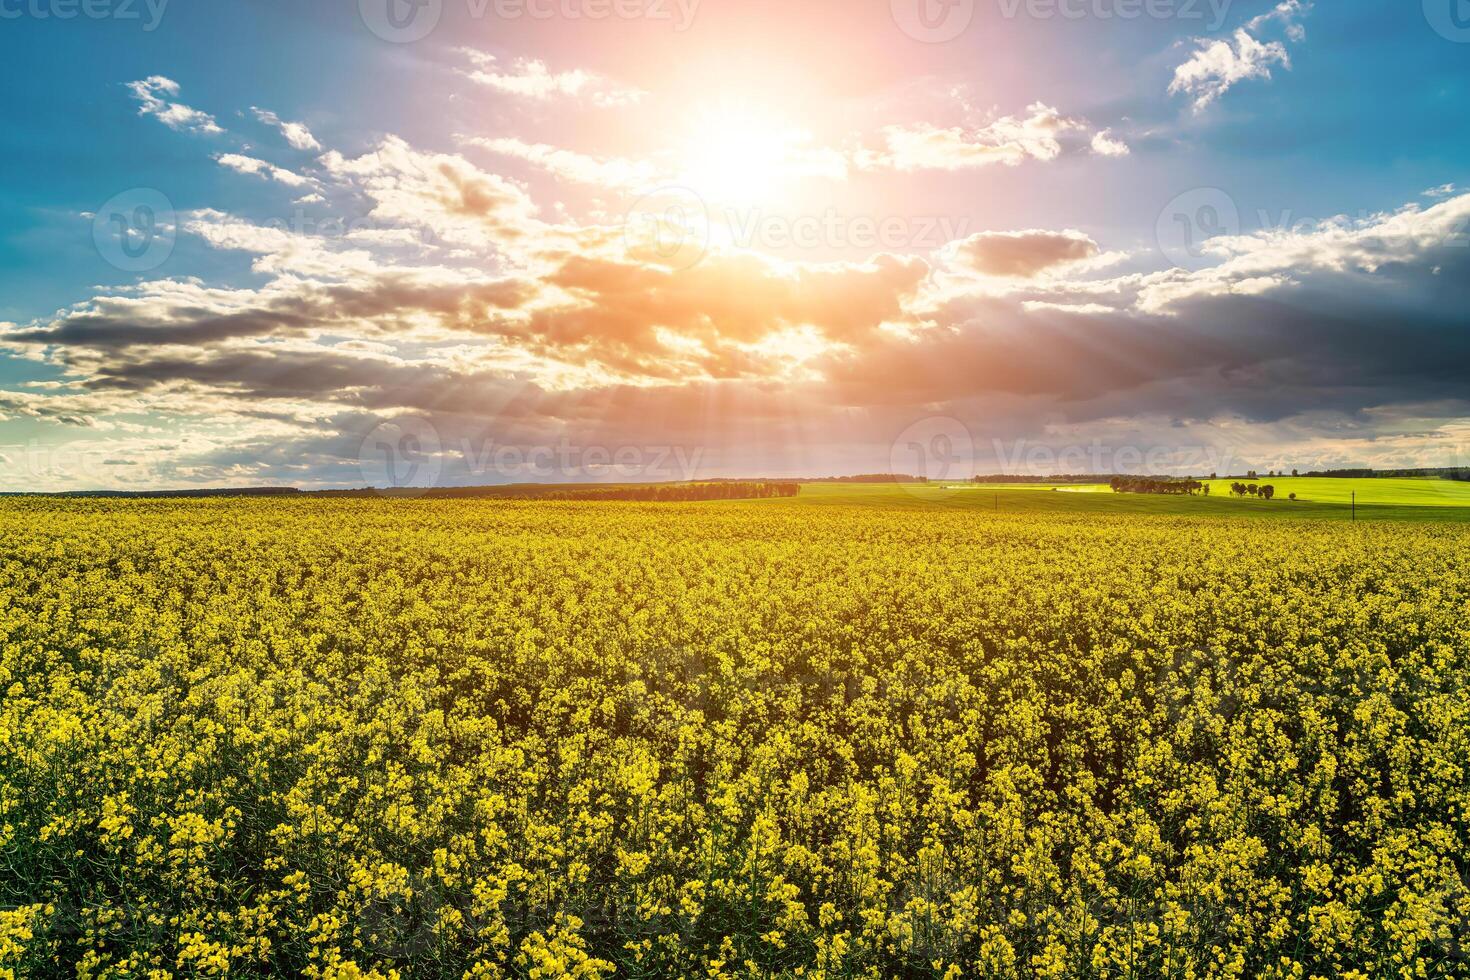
784, 476, 1470, 522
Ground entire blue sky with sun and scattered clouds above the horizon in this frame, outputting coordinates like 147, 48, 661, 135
0, 0, 1470, 491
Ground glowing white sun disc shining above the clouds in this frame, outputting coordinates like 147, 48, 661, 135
678, 109, 810, 207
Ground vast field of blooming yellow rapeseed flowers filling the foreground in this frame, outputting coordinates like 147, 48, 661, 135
0, 500, 1470, 980
